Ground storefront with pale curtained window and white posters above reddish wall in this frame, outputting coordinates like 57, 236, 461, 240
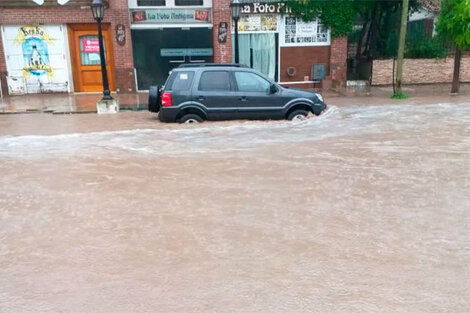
232, 2, 331, 87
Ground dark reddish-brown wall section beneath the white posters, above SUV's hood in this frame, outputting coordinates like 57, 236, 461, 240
279, 46, 330, 82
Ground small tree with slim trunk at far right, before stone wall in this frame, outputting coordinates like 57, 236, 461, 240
437, 0, 470, 93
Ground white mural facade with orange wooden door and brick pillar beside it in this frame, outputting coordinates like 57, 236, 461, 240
0, 0, 135, 95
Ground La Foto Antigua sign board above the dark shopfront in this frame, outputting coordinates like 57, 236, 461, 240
132, 9, 211, 24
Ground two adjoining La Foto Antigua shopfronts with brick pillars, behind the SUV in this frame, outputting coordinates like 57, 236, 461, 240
129, 0, 347, 90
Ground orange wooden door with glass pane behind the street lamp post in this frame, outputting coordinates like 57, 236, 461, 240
69, 24, 115, 92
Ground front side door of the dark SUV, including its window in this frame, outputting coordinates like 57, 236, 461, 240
234, 71, 284, 118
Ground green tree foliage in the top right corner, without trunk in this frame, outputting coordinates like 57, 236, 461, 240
437, 0, 470, 50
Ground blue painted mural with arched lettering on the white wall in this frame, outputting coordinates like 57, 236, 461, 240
15, 25, 54, 78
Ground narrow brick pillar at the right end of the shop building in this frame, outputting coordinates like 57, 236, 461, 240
330, 37, 348, 88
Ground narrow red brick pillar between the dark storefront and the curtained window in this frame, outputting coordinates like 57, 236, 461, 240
212, 0, 232, 63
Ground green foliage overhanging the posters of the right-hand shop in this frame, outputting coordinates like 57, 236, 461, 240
284, 0, 358, 38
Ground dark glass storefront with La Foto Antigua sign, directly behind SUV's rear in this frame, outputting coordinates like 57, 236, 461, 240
129, 0, 214, 90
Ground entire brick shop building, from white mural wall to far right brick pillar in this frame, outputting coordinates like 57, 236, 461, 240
0, 0, 347, 94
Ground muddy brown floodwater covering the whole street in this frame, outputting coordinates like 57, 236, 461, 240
0, 98, 470, 313
